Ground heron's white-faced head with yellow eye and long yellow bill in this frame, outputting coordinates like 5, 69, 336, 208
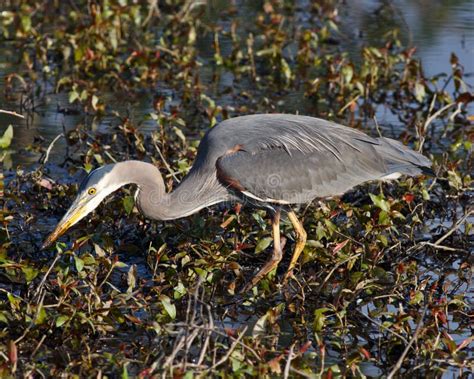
42, 164, 127, 249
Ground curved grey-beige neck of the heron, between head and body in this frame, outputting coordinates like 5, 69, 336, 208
117, 161, 227, 220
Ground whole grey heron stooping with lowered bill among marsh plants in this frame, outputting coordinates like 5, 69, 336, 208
44, 114, 432, 290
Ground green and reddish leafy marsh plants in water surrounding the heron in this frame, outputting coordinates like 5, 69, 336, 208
0, 0, 474, 378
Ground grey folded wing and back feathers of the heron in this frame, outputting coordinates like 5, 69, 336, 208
208, 115, 427, 203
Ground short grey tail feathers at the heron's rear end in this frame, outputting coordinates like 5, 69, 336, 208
375, 137, 435, 176
